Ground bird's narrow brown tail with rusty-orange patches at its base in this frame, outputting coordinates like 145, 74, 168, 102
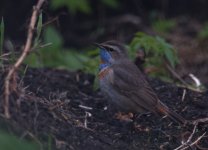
156, 101, 187, 125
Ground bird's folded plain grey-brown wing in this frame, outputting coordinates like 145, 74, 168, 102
112, 61, 158, 111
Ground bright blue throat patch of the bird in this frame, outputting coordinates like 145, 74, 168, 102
99, 49, 112, 70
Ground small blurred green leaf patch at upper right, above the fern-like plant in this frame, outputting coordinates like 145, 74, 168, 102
152, 19, 176, 33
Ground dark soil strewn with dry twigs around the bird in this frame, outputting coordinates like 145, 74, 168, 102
0, 69, 208, 150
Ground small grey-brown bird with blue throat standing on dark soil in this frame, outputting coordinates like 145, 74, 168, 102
95, 41, 187, 124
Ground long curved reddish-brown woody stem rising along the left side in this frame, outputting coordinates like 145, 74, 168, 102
4, 0, 45, 118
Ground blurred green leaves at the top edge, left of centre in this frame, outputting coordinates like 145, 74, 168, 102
51, 0, 91, 14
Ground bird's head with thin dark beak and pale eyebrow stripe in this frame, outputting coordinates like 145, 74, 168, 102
96, 41, 127, 65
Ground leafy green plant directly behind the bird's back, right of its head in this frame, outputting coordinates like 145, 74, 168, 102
130, 32, 179, 80
